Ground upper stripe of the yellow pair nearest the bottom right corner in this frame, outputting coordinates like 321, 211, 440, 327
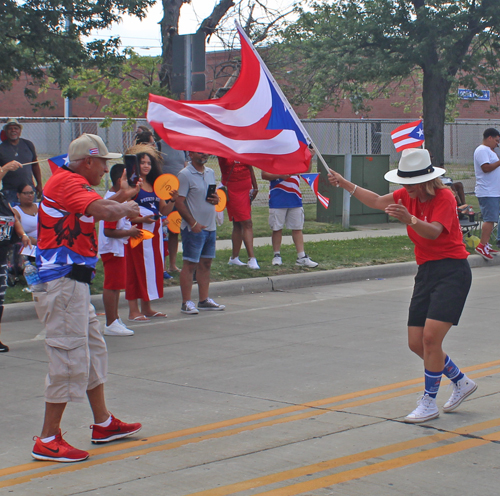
188, 418, 500, 496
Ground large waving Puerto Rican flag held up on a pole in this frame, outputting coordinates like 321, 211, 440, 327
147, 23, 311, 174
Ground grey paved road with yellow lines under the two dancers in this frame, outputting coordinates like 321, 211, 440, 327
0, 264, 500, 496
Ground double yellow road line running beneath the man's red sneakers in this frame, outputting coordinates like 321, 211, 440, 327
0, 360, 500, 488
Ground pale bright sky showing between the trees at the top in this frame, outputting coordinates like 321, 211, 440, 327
86, 0, 293, 56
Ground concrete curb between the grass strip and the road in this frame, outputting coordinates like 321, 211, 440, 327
2, 255, 500, 323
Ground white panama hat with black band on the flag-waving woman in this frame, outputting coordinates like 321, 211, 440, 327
384, 148, 446, 184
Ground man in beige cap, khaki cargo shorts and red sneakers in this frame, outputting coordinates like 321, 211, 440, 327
32, 134, 141, 462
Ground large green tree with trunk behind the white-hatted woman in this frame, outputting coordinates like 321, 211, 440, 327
276, 0, 500, 165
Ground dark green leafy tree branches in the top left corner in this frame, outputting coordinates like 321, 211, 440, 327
0, 0, 155, 97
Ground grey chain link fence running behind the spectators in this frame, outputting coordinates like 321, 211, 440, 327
0, 117, 500, 202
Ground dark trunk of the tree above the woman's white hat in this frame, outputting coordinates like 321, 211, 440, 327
422, 65, 450, 167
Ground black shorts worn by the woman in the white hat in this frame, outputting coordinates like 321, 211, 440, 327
408, 258, 472, 327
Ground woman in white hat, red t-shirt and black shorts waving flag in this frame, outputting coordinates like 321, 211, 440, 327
328, 148, 477, 423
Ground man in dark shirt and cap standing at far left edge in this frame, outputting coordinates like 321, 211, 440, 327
0, 119, 42, 204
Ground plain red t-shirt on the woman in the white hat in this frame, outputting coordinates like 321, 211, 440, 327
393, 188, 469, 265
